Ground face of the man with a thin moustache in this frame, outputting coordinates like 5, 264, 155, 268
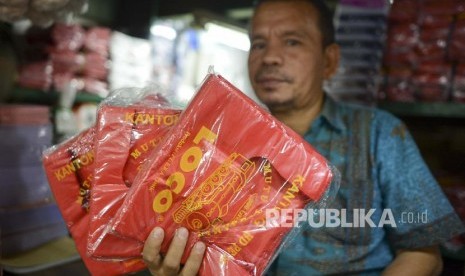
248, 1, 329, 112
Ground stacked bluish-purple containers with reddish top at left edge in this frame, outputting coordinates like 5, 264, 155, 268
0, 105, 68, 257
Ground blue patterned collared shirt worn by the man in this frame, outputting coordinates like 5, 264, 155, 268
269, 96, 463, 276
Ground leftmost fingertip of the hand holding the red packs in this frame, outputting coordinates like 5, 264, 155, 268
142, 227, 165, 271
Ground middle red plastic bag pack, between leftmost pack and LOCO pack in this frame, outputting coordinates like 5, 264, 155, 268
88, 89, 181, 259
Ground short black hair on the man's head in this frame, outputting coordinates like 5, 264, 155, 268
250, 0, 335, 47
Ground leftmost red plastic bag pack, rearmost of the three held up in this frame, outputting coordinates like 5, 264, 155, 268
43, 127, 145, 276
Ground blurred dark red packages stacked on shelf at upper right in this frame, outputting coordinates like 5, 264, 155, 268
379, 0, 465, 102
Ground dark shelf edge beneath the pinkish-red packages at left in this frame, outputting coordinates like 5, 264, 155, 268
8, 87, 103, 105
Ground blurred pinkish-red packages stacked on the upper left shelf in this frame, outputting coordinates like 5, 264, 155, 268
18, 23, 111, 97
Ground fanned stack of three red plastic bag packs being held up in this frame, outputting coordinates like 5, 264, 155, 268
44, 70, 339, 275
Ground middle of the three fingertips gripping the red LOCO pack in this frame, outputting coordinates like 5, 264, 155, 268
163, 227, 189, 272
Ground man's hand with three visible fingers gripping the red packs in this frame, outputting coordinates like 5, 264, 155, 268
142, 227, 205, 276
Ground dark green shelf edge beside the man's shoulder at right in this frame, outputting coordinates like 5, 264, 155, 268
378, 102, 465, 118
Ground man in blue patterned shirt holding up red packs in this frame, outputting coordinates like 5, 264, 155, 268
143, 0, 463, 275
